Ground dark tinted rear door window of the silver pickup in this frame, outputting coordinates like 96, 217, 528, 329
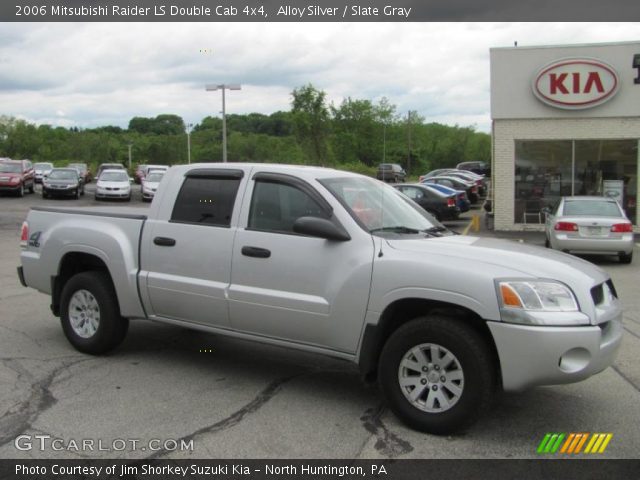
171, 177, 241, 227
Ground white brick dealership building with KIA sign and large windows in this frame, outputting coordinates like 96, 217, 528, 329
490, 42, 640, 231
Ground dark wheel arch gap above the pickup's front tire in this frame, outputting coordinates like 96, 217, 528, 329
358, 298, 501, 384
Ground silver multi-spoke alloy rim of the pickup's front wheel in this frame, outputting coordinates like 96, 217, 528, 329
398, 343, 464, 413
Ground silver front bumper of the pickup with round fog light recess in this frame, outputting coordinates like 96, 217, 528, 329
487, 313, 623, 391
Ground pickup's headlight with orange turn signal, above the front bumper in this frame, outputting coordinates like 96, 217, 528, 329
496, 280, 590, 326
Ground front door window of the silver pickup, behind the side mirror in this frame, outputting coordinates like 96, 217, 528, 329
248, 181, 329, 233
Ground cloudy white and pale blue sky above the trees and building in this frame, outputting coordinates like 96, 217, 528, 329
0, 23, 640, 131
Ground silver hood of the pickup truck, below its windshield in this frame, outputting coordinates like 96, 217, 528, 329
387, 235, 609, 285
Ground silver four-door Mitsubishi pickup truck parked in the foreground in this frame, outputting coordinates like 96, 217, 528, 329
18, 164, 622, 434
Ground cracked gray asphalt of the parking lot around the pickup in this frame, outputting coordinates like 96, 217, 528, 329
0, 188, 640, 459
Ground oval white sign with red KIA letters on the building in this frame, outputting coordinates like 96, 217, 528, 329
533, 58, 620, 110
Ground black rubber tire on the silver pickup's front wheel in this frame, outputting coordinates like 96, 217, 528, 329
378, 315, 497, 435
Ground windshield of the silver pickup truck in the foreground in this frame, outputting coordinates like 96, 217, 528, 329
320, 177, 440, 233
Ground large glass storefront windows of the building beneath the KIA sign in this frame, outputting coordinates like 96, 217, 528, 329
514, 140, 638, 224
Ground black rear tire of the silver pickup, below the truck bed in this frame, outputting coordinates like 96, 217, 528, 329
60, 271, 129, 355
